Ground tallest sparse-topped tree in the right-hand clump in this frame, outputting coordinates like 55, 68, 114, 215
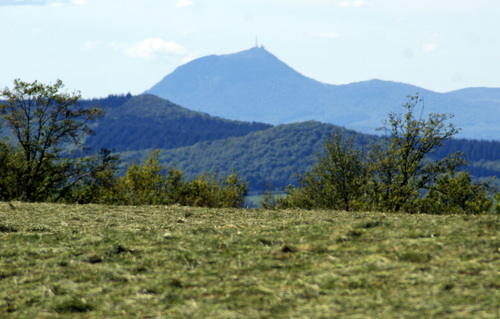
368, 95, 466, 212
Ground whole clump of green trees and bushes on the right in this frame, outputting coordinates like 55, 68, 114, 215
284, 96, 492, 214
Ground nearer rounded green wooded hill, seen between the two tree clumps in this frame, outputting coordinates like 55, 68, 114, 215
122, 121, 376, 190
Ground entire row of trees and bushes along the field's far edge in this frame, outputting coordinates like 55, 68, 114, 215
0, 80, 500, 214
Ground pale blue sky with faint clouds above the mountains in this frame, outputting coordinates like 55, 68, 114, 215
0, 0, 500, 98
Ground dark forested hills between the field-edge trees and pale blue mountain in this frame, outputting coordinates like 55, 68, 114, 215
76, 95, 500, 191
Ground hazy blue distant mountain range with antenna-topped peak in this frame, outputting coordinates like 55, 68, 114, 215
146, 47, 500, 139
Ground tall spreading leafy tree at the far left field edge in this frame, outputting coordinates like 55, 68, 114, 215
0, 80, 104, 201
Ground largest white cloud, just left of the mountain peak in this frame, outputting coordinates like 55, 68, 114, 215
112, 38, 187, 60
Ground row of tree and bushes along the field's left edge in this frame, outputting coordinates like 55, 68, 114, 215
0, 80, 248, 207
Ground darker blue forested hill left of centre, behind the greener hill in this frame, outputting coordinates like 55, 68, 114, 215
82, 94, 272, 152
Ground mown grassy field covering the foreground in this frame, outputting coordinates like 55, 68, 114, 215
0, 202, 500, 318
